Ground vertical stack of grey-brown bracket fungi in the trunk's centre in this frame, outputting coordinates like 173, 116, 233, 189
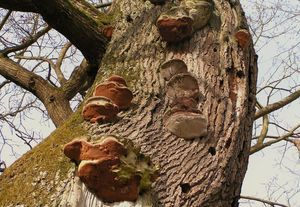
160, 59, 207, 139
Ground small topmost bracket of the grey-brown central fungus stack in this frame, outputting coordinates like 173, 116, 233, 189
160, 59, 188, 81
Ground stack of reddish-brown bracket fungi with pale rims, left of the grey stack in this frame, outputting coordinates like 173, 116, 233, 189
82, 75, 133, 123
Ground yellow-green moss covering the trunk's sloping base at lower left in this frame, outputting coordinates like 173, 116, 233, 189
0, 109, 87, 206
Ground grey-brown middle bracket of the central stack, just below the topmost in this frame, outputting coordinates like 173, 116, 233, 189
166, 73, 200, 100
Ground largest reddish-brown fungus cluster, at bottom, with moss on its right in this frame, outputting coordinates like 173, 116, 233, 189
64, 135, 158, 202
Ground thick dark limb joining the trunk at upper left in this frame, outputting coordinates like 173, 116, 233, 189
32, 0, 111, 65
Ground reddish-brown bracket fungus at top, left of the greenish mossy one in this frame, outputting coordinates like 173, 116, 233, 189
156, 7, 193, 42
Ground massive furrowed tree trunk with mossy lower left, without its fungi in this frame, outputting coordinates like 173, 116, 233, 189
0, 0, 257, 207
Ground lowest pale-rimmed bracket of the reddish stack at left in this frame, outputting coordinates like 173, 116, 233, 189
82, 96, 119, 123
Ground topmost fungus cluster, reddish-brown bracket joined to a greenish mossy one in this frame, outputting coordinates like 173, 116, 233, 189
156, 0, 213, 42
